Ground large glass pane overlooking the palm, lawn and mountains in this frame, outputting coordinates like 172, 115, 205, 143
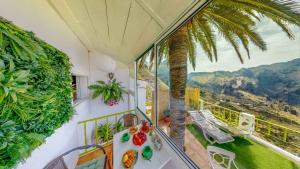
157, 0, 300, 169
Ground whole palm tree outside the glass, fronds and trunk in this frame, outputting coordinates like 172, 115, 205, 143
158, 0, 300, 149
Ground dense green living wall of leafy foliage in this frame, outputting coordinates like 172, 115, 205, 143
0, 17, 74, 169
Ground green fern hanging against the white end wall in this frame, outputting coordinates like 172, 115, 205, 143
89, 79, 125, 106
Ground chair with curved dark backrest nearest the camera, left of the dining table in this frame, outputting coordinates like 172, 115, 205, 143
44, 144, 111, 169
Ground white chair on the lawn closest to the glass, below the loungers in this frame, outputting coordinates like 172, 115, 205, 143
207, 146, 238, 169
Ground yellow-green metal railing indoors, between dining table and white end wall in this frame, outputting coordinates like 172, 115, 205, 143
78, 109, 136, 155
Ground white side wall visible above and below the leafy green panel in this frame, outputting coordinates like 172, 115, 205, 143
0, 0, 89, 169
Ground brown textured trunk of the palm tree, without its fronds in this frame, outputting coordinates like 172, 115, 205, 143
169, 27, 188, 149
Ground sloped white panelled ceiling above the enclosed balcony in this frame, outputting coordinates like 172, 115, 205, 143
48, 0, 196, 63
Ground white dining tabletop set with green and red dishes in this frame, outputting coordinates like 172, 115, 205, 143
113, 129, 171, 169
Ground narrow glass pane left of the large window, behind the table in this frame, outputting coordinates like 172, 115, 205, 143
136, 49, 155, 122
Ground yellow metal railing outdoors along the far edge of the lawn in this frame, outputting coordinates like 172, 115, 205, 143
200, 99, 300, 153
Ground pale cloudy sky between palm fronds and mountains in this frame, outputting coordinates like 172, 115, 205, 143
188, 19, 300, 72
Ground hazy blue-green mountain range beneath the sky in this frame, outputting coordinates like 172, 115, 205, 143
188, 58, 300, 106
